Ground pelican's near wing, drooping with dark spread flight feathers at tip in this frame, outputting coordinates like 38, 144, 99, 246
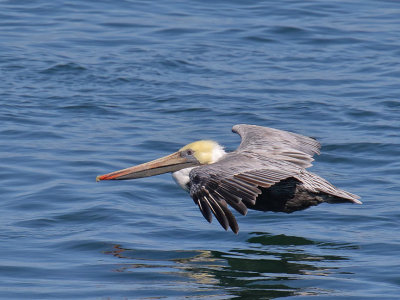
189, 152, 302, 233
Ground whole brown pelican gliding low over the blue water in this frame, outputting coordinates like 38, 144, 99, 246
96, 124, 361, 233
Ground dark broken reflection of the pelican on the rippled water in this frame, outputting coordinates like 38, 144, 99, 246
105, 232, 357, 299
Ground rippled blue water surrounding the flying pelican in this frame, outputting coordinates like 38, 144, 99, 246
0, 0, 400, 300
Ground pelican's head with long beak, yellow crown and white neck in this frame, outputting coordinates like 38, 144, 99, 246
96, 140, 225, 189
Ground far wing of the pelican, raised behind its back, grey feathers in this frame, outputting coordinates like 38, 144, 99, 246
232, 124, 321, 168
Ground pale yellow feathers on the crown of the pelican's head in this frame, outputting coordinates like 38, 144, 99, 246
179, 140, 225, 165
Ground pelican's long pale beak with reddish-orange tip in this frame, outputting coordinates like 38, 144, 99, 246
96, 152, 198, 181
